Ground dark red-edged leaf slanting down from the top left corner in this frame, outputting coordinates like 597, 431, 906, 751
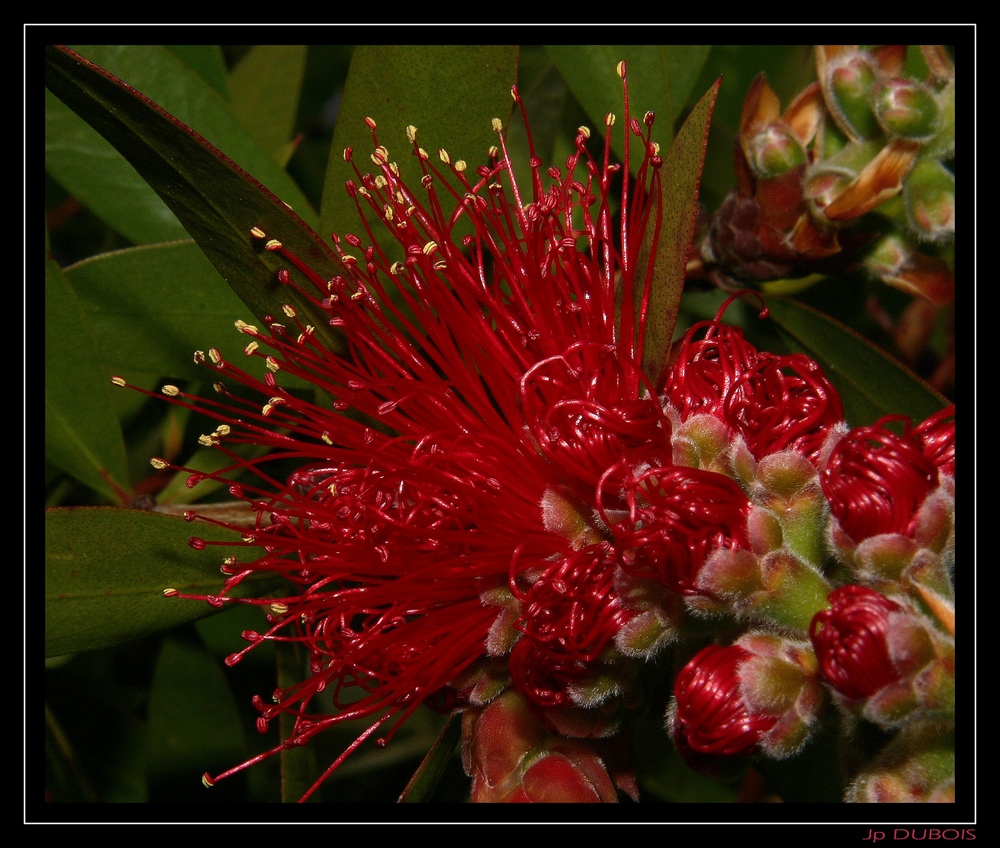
45, 47, 343, 352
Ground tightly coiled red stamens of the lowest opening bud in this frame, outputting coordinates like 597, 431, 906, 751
671, 645, 778, 763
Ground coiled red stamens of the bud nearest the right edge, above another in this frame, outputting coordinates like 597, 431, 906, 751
820, 410, 954, 542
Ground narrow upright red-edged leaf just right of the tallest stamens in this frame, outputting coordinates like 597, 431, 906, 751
636, 75, 721, 385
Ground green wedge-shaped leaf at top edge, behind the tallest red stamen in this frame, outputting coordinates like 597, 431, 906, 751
545, 44, 712, 151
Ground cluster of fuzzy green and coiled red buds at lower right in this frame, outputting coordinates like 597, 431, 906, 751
667, 314, 955, 801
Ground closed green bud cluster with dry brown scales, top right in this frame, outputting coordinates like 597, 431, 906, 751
692, 45, 955, 306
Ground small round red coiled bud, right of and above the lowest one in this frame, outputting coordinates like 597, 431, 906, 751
809, 585, 903, 700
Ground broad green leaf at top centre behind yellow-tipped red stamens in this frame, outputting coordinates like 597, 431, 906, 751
320, 45, 518, 250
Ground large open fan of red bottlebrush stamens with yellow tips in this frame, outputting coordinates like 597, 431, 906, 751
115, 65, 684, 797
